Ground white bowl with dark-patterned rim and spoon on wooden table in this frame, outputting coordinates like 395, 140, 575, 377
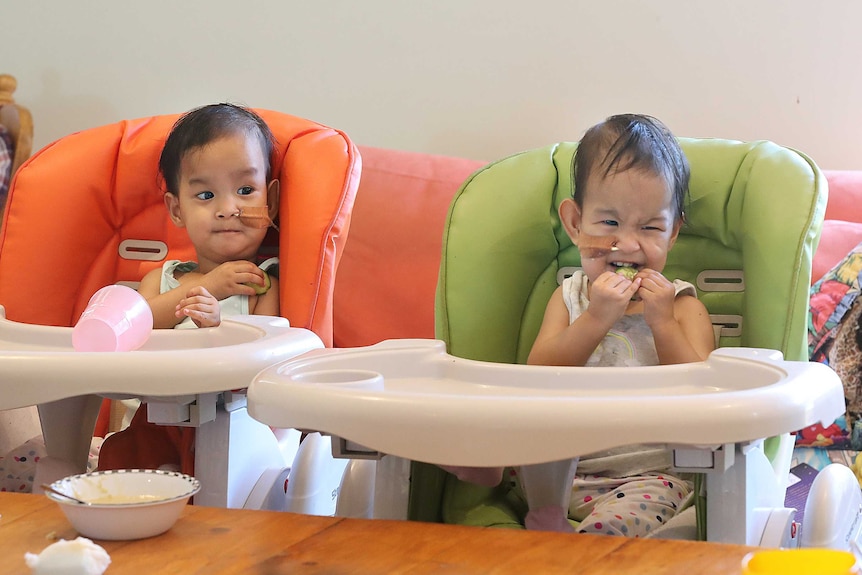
45, 469, 201, 540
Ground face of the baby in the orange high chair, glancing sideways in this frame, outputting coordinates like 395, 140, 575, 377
168, 132, 271, 271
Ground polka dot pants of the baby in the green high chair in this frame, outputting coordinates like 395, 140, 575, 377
569, 474, 692, 537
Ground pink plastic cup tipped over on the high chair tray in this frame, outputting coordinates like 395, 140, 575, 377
72, 285, 153, 351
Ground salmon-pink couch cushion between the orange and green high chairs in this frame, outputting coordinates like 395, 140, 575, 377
333, 146, 485, 347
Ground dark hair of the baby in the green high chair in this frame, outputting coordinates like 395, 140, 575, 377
572, 114, 691, 221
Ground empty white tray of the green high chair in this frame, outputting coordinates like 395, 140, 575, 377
248, 340, 844, 466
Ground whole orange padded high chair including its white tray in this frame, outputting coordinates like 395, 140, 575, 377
0, 110, 361, 507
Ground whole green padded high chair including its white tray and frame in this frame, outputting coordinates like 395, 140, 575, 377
249, 134, 844, 547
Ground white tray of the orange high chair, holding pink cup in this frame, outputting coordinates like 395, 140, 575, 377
0, 306, 323, 410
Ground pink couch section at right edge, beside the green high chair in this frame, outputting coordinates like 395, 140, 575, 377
811, 170, 862, 283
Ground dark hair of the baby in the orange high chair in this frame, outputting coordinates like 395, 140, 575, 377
159, 104, 276, 194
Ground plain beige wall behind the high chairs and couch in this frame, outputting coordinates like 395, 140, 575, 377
6, 0, 862, 169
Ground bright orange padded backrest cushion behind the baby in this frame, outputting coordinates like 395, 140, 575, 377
0, 110, 361, 345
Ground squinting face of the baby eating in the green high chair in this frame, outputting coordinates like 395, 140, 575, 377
573, 169, 679, 281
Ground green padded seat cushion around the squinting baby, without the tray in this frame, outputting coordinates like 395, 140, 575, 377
408, 138, 827, 543
